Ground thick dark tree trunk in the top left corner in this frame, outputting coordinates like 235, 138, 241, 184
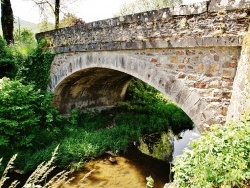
1, 0, 14, 44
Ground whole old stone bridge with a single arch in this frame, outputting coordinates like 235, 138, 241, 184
36, 0, 250, 130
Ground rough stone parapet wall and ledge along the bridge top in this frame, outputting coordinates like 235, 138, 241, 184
36, 0, 249, 52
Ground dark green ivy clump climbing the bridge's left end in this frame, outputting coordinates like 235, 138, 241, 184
17, 41, 54, 92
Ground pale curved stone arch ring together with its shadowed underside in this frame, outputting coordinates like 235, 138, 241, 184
49, 51, 216, 131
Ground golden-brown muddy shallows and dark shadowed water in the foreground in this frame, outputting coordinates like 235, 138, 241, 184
63, 147, 169, 188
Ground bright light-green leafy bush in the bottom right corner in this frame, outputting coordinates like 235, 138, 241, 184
173, 120, 250, 188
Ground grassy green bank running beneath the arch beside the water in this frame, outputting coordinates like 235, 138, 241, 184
12, 97, 192, 171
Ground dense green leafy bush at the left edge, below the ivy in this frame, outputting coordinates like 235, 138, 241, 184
0, 78, 41, 147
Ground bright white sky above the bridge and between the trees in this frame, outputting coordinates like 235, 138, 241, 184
11, 0, 205, 23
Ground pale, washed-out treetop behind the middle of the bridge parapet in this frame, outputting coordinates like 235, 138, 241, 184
114, 0, 182, 16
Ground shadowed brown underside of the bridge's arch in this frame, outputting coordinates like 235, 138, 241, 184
53, 68, 133, 114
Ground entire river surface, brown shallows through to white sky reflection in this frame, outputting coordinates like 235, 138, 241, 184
61, 129, 200, 188
